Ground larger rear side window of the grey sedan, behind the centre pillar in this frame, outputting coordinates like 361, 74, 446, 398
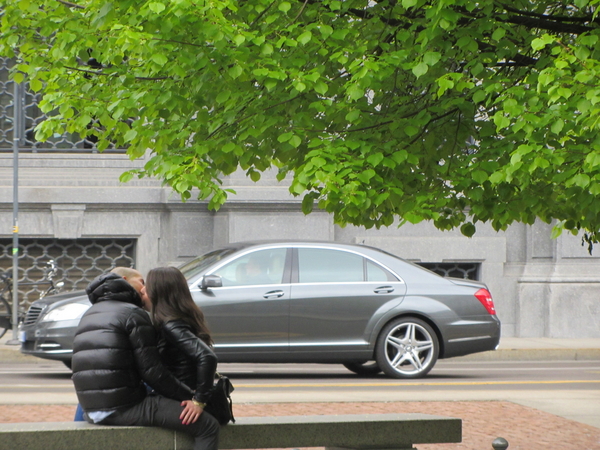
298, 248, 365, 283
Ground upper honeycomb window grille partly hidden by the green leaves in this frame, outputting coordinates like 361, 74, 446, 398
0, 57, 125, 153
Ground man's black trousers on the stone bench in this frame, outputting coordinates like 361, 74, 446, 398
95, 395, 220, 450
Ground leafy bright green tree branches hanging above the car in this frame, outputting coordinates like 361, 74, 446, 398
0, 0, 600, 243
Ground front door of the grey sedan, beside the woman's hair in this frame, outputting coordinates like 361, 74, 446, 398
192, 247, 290, 362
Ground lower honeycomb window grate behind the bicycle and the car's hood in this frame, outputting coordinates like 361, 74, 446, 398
0, 238, 136, 307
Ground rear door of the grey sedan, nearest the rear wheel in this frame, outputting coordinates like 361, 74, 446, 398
290, 247, 406, 356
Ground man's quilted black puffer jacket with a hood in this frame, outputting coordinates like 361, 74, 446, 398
72, 273, 192, 411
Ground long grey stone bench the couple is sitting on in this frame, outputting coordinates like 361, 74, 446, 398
0, 414, 462, 450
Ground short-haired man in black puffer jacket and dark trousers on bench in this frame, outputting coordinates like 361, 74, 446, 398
72, 269, 219, 450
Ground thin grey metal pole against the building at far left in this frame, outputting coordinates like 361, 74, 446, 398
7, 78, 21, 345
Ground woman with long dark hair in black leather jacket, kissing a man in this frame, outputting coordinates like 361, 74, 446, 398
143, 267, 217, 422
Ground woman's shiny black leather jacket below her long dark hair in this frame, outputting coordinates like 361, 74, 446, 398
158, 320, 217, 403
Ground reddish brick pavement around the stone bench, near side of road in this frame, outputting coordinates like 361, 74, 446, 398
0, 401, 600, 450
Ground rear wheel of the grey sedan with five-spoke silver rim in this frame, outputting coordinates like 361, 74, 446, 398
375, 317, 439, 378
